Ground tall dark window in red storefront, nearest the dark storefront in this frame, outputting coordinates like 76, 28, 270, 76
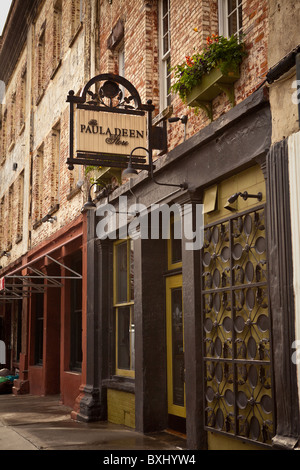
70, 253, 82, 371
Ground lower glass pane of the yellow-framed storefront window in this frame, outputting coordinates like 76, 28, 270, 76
117, 307, 130, 369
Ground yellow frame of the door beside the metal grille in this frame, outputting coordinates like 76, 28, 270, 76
166, 274, 186, 418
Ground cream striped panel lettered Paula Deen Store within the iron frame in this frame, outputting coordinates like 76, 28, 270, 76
75, 109, 147, 157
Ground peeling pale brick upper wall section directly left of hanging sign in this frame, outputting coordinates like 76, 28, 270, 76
31, 0, 85, 247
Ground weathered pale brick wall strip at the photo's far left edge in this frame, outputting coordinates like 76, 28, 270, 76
0, 48, 30, 266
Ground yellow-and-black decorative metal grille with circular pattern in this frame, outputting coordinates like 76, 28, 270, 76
202, 206, 273, 444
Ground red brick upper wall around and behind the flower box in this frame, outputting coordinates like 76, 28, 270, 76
99, 0, 268, 149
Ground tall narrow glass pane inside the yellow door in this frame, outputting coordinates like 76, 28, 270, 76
172, 287, 184, 406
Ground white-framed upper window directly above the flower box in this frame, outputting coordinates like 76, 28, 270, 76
219, 0, 243, 37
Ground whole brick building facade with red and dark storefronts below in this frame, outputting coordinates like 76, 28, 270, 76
0, 0, 299, 449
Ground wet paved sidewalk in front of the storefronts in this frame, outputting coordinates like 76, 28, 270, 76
0, 395, 186, 451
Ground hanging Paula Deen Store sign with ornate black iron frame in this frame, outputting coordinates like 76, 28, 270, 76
67, 74, 154, 172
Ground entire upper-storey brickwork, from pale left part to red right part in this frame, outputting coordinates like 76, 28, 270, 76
0, 0, 268, 265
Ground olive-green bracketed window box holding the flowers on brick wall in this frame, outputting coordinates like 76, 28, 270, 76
186, 68, 240, 121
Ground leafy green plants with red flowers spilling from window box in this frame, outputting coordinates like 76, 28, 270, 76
171, 34, 247, 109
